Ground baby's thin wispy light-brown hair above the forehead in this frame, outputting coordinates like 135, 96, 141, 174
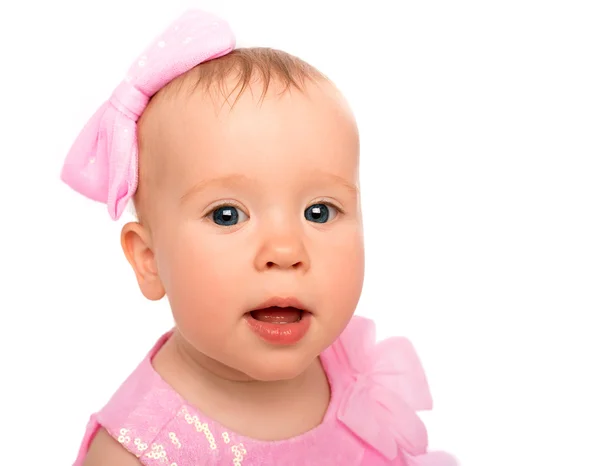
128, 47, 329, 221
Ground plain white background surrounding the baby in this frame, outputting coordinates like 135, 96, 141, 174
0, 0, 600, 466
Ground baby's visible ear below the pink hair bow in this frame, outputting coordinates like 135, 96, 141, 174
121, 222, 165, 301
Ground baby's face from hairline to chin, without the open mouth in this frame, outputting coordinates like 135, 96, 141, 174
134, 77, 364, 380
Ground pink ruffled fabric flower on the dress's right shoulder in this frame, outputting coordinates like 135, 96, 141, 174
337, 318, 432, 460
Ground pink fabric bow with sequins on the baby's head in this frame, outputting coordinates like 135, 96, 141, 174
61, 10, 235, 220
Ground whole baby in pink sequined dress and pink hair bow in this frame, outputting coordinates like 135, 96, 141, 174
62, 7, 456, 466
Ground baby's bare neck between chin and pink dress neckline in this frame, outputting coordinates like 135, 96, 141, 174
153, 332, 330, 440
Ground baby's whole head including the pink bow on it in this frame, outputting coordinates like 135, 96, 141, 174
61, 10, 364, 381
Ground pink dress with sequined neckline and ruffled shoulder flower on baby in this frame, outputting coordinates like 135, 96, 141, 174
74, 317, 457, 466
